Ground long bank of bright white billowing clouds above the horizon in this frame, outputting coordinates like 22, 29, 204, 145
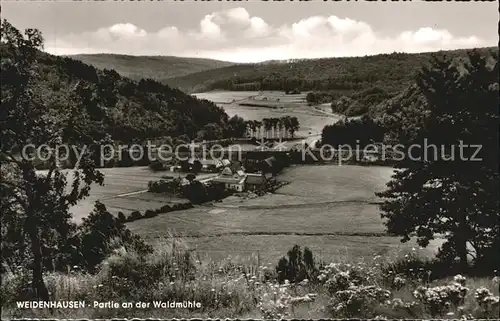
46, 8, 493, 62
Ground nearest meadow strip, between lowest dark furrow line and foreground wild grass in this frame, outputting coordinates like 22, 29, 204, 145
184, 235, 434, 262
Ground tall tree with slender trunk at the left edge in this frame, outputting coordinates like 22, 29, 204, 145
0, 20, 103, 300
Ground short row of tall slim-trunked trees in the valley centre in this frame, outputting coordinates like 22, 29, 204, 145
246, 116, 300, 138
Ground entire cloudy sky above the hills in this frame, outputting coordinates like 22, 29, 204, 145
2, 0, 499, 62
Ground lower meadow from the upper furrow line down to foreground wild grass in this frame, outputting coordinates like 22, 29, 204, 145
128, 203, 442, 264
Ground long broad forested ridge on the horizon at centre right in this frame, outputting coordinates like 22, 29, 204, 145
162, 48, 492, 92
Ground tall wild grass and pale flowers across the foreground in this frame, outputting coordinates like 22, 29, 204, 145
1, 236, 499, 319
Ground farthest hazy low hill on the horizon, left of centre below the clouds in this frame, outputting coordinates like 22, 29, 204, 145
68, 54, 233, 80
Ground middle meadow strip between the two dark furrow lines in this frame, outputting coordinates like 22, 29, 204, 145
130, 202, 384, 238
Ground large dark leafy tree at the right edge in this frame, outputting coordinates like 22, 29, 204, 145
378, 52, 500, 273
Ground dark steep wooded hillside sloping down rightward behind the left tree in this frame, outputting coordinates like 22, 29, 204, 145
0, 46, 228, 142
